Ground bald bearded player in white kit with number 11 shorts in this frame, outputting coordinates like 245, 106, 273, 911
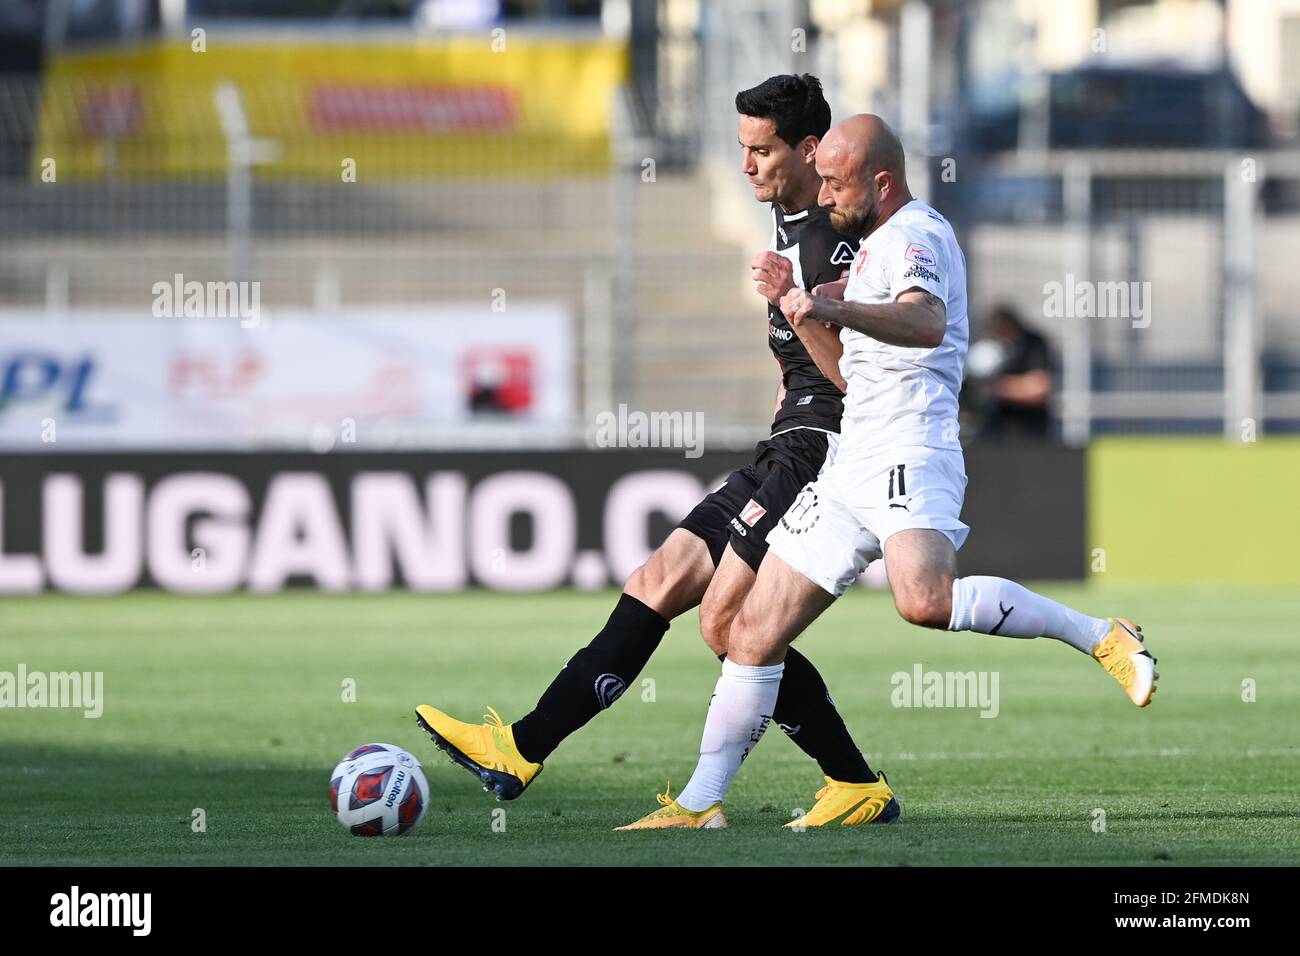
619, 114, 1158, 830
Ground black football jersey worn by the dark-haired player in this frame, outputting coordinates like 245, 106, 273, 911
767, 203, 858, 432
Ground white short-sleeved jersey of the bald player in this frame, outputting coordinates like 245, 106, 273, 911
839, 199, 970, 460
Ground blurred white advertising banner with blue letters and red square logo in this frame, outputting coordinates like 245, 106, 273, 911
0, 302, 575, 451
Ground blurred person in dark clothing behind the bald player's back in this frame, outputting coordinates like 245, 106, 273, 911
962, 304, 1053, 441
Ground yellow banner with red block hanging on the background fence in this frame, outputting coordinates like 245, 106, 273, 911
31, 35, 627, 179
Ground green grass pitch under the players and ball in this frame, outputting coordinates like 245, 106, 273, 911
0, 587, 1300, 865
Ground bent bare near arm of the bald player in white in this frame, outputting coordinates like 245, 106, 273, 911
781, 289, 948, 349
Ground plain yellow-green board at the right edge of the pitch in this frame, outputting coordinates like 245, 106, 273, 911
1088, 438, 1300, 587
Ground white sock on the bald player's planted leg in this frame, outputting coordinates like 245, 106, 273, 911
677, 659, 785, 810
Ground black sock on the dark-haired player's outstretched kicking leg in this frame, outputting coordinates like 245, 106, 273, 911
511, 594, 670, 763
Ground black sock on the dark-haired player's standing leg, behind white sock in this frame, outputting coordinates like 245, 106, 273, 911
772, 648, 876, 783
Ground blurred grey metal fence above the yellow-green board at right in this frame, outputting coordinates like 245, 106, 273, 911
967, 150, 1300, 444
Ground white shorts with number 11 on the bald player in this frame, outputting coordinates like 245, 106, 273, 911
767, 447, 970, 597
